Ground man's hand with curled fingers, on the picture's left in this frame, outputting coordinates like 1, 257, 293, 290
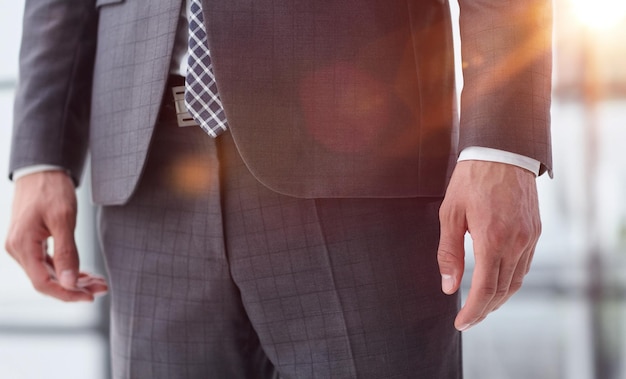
6, 171, 107, 301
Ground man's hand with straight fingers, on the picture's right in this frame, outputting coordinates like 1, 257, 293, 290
437, 161, 541, 331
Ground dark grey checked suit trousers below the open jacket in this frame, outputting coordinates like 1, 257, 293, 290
100, 91, 462, 379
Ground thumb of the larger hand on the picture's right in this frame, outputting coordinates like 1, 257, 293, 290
437, 208, 467, 295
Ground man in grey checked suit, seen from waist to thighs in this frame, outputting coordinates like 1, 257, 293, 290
7, 0, 551, 378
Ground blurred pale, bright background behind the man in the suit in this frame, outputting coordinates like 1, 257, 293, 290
0, 0, 626, 379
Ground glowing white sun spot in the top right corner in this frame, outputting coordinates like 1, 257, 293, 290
570, 0, 626, 29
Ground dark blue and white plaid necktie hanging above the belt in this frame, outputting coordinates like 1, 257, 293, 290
185, 0, 228, 137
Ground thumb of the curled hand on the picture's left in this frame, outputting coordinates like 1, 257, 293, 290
52, 228, 79, 289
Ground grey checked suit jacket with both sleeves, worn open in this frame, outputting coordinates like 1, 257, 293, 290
10, 0, 551, 204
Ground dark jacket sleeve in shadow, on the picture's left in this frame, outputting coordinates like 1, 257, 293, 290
9, 0, 97, 184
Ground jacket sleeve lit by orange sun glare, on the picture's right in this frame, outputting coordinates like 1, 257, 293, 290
459, 0, 552, 175
